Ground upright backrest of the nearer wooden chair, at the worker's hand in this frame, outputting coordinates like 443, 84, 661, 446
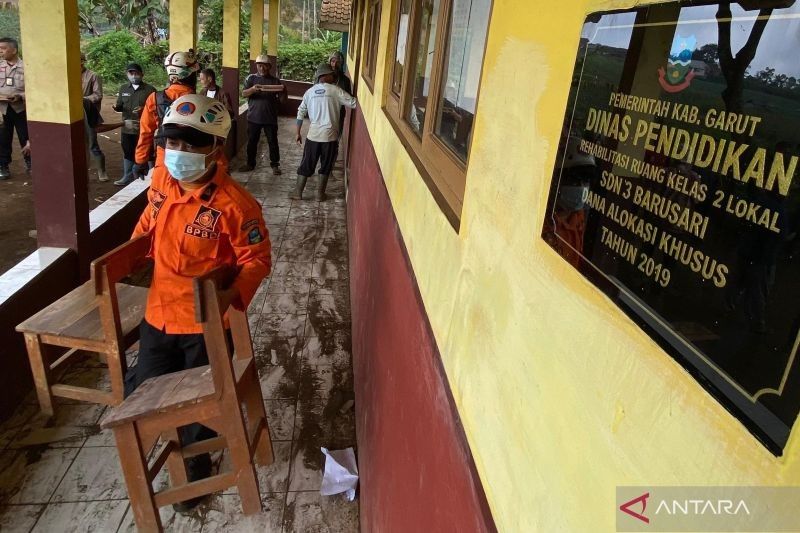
194, 266, 253, 398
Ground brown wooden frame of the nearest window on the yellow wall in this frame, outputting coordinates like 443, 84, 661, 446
383, 0, 494, 231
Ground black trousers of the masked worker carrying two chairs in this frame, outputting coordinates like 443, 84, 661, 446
125, 320, 217, 446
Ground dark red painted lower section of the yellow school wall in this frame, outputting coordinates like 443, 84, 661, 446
348, 109, 496, 533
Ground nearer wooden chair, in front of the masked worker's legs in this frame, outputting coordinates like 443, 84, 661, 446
101, 268, 273, 531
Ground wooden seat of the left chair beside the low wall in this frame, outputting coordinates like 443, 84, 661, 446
17, 280, 147, 346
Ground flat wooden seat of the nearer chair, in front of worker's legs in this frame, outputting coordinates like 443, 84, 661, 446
102, 359, 253, 428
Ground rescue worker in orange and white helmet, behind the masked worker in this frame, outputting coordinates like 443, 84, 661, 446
134, 50, 200, 172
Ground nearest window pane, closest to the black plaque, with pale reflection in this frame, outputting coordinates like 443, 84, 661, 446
435, 0, 492, 161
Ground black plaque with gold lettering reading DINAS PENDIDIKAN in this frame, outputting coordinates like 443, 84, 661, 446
543, 0, 800, 455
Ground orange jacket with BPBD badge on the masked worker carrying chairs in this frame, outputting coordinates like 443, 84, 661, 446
133, 158, 272, 334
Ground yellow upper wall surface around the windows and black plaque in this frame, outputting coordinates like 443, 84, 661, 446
351, 0, 800, 532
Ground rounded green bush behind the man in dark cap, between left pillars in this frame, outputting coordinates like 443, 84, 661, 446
85, 30, 151, 89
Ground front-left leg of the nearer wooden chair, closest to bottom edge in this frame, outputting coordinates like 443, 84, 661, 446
114, 423, 163, 533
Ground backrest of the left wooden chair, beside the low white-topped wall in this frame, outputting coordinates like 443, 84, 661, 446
90, 234, 150, 345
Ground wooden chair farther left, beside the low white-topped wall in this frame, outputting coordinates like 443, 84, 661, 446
17, 235, 150, 416
